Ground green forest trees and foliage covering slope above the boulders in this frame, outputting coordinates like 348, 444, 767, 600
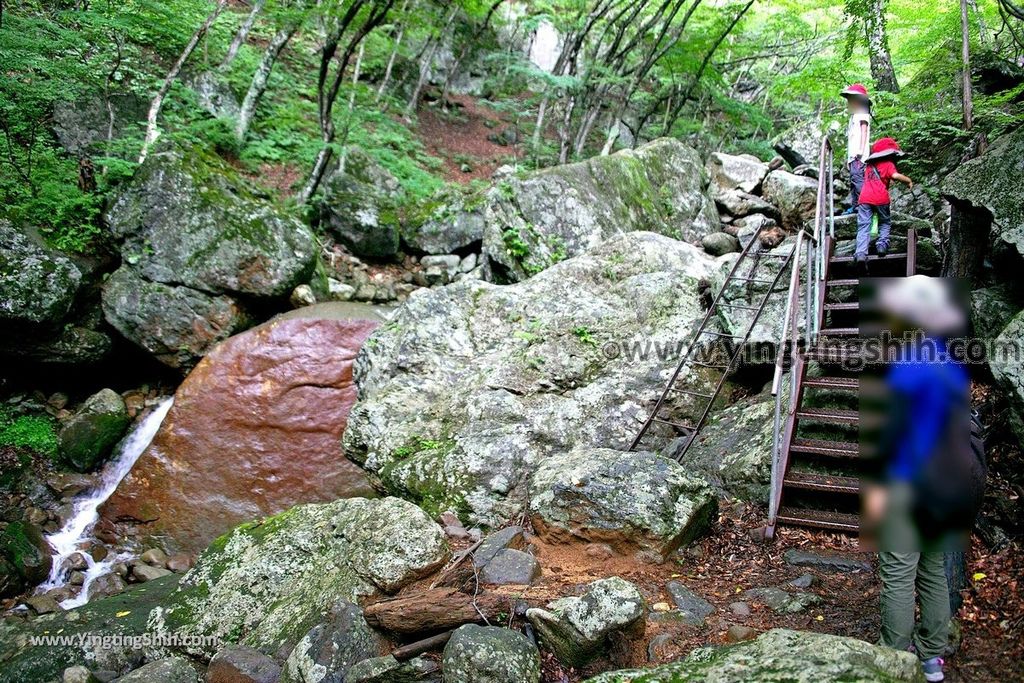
0, 0, 1024, 251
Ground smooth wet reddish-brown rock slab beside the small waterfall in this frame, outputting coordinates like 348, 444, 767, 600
101, 305, 378, 552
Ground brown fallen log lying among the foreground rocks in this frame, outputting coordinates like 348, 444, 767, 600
364, 588, 510, 633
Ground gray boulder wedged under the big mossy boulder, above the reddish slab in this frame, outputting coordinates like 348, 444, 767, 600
102, 265, 249, 370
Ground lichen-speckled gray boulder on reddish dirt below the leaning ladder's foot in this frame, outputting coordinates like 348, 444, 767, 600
529, 449, 717, 556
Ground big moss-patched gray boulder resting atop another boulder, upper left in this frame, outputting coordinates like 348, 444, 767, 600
106, 147, 316, 297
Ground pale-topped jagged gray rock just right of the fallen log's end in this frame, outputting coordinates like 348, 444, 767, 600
526, 577, 646, 667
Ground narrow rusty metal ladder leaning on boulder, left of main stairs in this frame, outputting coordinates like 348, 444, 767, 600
629, 226, 800, 461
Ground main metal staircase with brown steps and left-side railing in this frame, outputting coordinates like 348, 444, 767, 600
766, 138, 916, 538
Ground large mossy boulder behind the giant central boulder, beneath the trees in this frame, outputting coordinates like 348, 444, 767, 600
475, 138, 719, 280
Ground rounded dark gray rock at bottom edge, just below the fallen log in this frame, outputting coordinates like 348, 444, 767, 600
441, 624, 541, 683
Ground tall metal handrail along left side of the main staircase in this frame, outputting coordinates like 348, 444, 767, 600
767, 135, 836, 535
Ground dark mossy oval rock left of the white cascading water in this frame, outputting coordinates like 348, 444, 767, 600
59, 389, 130, 471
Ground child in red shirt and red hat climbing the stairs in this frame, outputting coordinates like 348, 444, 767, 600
855, 137, 913, 272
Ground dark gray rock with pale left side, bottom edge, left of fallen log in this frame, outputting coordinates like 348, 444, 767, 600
281, 600, 383, 683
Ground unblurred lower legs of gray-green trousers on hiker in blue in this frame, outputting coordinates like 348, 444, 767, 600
879, 552, 949, 659
